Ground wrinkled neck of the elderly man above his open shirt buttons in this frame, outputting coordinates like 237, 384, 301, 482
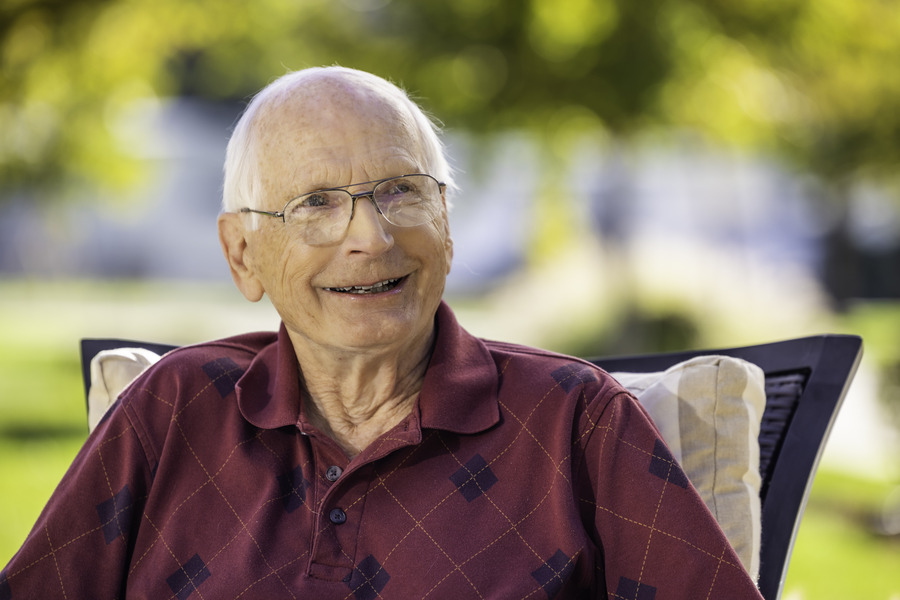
292, 326, 434, 458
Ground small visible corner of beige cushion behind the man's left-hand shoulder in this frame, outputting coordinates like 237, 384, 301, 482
88, 348, 159, 431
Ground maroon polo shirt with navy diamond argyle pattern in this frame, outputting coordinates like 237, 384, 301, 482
0, 306, 759, 600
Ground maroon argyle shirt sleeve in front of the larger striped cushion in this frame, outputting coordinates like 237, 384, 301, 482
574, 393, 761, 600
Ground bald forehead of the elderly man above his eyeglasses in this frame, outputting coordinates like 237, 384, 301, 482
255, 79, 424, 199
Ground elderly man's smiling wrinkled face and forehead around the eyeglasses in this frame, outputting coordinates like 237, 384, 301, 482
237, 79, 452, 352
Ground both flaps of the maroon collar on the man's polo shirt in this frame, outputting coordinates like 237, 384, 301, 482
236, 302, 500, 434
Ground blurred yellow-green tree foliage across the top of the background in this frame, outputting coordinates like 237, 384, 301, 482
0, 0, 900, 205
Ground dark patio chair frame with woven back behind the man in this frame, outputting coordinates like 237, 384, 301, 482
81, 335, 862, 600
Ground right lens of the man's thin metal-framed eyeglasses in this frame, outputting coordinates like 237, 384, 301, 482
372, 175, 441, 227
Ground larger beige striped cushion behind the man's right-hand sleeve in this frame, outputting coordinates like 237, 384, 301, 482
612, 356, 766, 579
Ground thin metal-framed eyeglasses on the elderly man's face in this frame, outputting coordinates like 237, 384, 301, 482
240, 173, 445, 245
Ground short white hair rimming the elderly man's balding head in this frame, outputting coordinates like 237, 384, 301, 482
222, 66, 456, 212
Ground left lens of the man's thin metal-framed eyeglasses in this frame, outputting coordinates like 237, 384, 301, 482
284, 190, 352, 244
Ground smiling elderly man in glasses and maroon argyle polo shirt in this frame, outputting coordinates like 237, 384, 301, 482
0, 67, 759, 600
